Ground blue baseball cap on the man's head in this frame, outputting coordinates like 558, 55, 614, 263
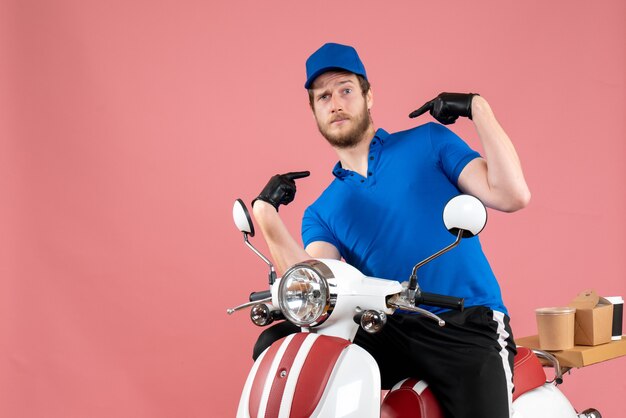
304, 43, 367, 89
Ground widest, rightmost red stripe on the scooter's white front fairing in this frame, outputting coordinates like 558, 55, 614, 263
289, 335, 350, 417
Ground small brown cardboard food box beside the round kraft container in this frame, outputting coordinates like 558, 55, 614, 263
569, 290, 613, 345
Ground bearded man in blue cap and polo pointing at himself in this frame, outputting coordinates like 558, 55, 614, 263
253, 44, 530, 418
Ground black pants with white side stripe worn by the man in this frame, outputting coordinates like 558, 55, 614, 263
253, 306, 516, 418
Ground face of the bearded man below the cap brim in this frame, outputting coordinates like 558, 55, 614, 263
312, 72, 372, 148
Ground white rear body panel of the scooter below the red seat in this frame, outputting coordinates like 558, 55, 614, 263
513, 383, 578, 418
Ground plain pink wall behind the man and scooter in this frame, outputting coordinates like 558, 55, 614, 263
0, 0, 626, 418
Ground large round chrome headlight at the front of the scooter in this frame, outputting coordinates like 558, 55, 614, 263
278, 260, 335, 327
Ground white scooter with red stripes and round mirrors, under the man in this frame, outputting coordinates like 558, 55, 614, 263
228, 195, 601, 418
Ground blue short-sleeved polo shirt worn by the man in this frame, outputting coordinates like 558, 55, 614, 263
302, 123, 507, 314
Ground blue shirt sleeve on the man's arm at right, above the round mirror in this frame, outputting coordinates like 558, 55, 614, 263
429, 123, 480, 184
